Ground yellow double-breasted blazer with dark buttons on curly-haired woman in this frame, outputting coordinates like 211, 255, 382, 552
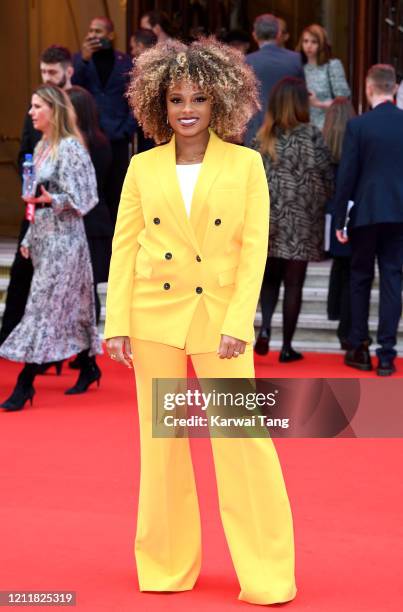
105, 131, 269, 352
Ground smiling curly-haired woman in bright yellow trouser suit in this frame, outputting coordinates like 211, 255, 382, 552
105, 39, 296, 604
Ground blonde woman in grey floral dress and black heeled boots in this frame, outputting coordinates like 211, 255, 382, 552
0, 85, 101, 411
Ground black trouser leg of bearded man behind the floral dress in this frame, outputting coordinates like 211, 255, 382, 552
0, 219, 34, 344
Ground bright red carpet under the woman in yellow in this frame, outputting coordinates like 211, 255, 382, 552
0, 354, 403, 612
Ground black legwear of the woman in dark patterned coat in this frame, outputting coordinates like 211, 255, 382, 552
260, 257, 308, 349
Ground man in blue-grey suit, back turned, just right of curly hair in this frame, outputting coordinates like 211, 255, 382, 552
244, 13, 305, 146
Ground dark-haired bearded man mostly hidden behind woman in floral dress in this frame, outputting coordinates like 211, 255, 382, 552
0, 45, 73, 344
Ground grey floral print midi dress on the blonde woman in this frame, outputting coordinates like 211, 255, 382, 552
0, 137, 102, 364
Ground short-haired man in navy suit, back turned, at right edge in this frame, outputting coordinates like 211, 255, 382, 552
336, 64, 403, 376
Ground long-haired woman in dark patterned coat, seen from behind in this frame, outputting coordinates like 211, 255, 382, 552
255, 77, 334, 362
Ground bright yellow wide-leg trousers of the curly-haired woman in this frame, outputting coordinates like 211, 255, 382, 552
131, 339, 296, 604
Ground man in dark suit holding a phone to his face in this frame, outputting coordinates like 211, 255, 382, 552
72, 17, 136, 223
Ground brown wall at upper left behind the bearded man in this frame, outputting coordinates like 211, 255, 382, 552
0, 0, 126, 235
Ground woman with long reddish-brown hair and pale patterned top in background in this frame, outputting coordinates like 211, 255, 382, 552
296, 23, 351, 130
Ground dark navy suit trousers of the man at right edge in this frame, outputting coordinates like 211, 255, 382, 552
349, 223, 403, 359
